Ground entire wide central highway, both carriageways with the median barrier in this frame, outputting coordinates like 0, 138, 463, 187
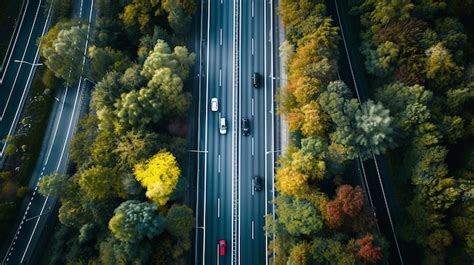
192, 0, 275, 264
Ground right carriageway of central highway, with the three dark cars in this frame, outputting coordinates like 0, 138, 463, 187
239, 0, 272, 264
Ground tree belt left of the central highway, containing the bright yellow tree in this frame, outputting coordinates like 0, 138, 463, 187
31, 0, 195, 264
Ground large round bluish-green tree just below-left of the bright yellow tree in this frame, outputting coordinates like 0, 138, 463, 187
109, 201, 164, 242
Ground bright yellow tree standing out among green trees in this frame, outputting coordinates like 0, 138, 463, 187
134, 150, 181, 206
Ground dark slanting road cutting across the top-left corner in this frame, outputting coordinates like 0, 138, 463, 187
0, 0, 51, 167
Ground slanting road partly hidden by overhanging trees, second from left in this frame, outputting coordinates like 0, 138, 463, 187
0, 0, 95, 264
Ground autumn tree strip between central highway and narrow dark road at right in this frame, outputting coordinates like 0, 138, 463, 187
267, 0, 394, 264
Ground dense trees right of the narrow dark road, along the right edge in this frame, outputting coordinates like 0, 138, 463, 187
353, 0, 474, 265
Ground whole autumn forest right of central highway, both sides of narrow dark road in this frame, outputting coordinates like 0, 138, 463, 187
267, 0, 474, 264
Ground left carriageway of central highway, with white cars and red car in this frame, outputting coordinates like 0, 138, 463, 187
196, 0, 235, 264
